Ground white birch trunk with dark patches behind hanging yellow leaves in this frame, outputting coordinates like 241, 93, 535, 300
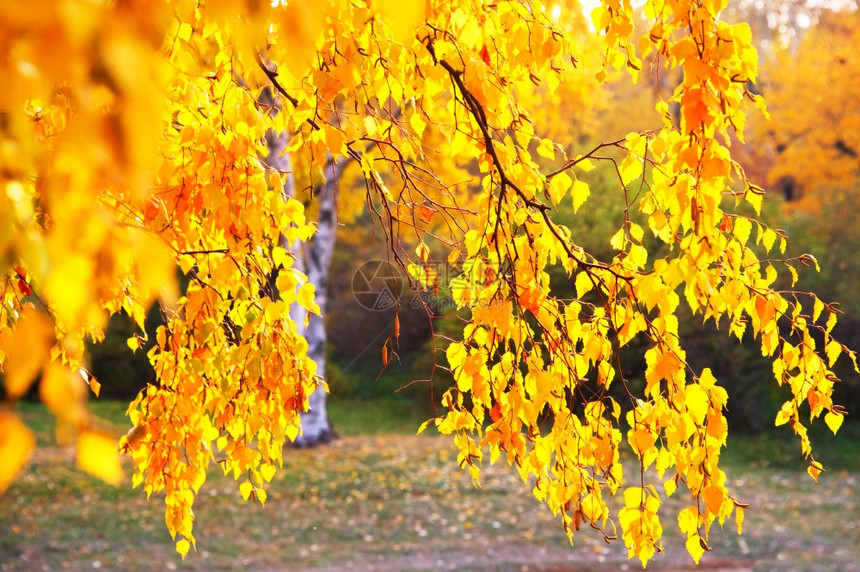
266, 128, 342, 447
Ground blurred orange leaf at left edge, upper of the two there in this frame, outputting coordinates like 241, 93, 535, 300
0, 307, 54, 399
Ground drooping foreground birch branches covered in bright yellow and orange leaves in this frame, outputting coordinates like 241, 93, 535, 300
0, 0, 854, 564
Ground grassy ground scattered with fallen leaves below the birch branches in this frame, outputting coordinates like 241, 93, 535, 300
0, 401, 860, 571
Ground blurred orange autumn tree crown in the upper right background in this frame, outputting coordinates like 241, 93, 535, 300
755, 9, 860, 206
